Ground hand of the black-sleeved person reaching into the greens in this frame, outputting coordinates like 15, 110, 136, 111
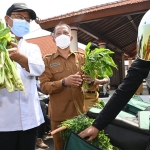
79, 126, 99, 142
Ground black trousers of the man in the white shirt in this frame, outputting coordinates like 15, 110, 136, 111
0, 128, 36, 150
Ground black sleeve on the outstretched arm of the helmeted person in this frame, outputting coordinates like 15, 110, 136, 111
93, 59, 150, 130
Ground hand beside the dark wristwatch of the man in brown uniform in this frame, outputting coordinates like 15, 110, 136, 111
65, 72, 83, 86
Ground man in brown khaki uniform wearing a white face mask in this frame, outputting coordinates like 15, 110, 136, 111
40, 24, 92, 150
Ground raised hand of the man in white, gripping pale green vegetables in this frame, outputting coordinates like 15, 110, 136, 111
7, 42, 21, 62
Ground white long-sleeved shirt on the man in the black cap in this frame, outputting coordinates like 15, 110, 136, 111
0, 39, 45, 131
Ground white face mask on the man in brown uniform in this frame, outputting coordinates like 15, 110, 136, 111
55, 34, 70, 49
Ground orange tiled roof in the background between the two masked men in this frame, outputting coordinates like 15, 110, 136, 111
26, 36, 84, 56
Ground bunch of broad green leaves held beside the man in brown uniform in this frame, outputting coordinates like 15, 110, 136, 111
82, 42, 117, 88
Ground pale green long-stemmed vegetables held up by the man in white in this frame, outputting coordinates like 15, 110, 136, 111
0, 20, 25, 92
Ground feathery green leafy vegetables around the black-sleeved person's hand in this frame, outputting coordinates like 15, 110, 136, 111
59, 114, 119, 150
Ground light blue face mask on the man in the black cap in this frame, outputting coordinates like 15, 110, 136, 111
11, 18, 30, 37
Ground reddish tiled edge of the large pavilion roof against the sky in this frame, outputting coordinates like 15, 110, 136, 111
36, 0, 149, 24
